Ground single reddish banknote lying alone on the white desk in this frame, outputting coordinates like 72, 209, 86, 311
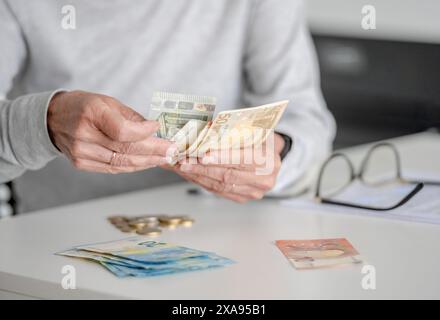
276, 239, 362, 269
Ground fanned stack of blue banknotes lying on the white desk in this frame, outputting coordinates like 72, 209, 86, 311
56, 236, 233, 277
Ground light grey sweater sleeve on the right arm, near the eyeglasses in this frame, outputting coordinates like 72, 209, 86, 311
244, 0, 335, 196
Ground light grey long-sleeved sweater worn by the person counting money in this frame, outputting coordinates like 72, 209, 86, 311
0, 0, 335, 200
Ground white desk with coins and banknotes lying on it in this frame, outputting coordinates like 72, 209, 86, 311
0, 133, 440, 299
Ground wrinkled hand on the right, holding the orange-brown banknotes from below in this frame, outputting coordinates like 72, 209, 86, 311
165, 134, 284, 203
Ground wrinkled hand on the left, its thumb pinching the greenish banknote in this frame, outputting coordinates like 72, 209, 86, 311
47, 91, 172, 173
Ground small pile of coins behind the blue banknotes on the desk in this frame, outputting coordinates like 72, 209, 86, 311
108, 214, 194, 237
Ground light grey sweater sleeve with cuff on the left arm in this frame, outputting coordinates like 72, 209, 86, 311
0, 0, 60, 183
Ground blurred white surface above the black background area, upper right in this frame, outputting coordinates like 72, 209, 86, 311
305, 0, 440, 43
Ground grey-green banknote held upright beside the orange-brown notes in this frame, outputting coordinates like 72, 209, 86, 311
149, 92, 216, 139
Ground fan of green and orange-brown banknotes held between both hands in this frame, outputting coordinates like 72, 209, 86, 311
149, 92, 288, 163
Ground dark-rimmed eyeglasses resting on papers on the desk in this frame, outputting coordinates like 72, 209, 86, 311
315, 142, 440, 211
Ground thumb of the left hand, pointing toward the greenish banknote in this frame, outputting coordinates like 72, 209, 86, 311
94, 107, 159, 142
